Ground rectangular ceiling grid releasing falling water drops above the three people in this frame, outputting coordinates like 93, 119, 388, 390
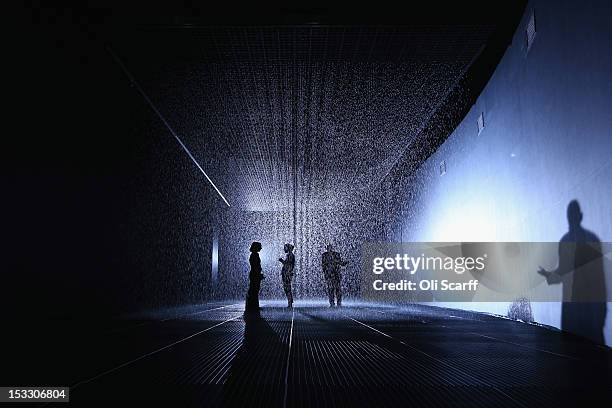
111, 25, 494, 210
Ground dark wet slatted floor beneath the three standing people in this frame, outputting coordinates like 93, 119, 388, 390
2, 301, 612, 407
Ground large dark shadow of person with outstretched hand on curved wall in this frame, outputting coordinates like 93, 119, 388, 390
538, 200, 607, 344
